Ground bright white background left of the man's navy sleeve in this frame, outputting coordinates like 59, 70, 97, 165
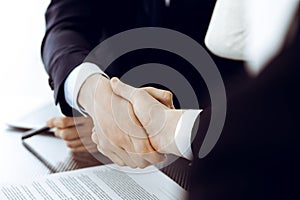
0, 0, 53, 124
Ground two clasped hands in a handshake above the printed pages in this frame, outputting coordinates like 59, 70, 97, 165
78, 74, 184, 168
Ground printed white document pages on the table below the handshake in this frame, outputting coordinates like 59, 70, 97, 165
0, 164, 187, 200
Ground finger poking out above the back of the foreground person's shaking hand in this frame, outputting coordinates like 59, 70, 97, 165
142, 87, 174, 109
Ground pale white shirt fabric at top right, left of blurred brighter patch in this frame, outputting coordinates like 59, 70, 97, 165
205, 0, 248, 60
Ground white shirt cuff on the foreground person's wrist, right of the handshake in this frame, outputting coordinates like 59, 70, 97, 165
175, 110, 202, 160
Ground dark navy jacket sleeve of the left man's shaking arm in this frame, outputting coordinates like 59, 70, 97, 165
42, 0, 101, 115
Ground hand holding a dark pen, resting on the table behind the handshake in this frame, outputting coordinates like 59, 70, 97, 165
47, 117, 97, 152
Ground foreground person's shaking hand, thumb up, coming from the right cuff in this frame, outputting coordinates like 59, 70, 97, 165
111, 78, 183, 156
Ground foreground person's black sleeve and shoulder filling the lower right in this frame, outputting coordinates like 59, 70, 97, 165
190, 30, 300, 200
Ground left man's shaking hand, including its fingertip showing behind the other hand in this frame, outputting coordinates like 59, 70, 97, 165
78, 75, 173, 168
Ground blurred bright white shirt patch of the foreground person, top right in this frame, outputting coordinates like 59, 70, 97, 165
244, 0, 299, 76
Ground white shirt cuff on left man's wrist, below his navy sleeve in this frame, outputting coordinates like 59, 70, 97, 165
64, 62, 108, 115
